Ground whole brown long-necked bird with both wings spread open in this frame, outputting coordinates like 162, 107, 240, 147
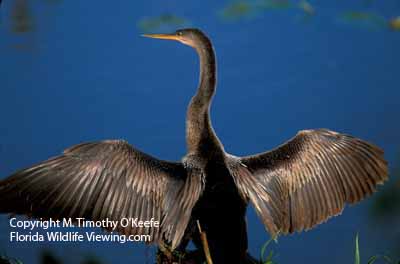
0, 28, 388, 264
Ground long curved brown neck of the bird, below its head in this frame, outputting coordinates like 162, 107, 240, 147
186, 39, 220, 153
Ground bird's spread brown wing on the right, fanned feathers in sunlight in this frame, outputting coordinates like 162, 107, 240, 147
233, 129, 388, 235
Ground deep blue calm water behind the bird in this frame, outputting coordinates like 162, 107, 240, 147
0, 0, 400, 263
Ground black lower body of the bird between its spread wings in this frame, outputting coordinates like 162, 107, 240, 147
192, 158, 247, 263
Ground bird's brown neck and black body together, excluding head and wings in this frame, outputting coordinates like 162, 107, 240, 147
175, 29, 247, 263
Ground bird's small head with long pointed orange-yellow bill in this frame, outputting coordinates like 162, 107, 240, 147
142, 28, 209, 48
